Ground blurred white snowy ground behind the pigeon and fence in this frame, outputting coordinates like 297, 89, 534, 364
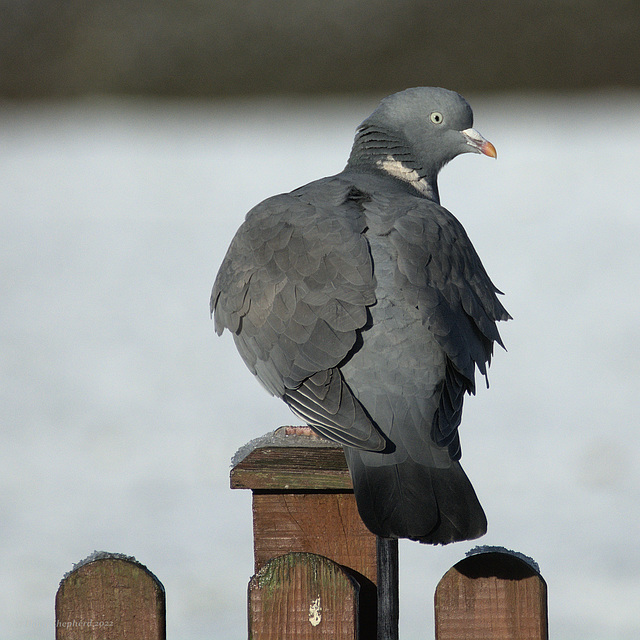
0, 93, 640, 640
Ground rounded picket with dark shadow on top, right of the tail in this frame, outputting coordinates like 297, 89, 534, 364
435, 550, 548, 640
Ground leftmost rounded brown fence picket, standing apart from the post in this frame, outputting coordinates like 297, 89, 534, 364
56, 552, 166, 640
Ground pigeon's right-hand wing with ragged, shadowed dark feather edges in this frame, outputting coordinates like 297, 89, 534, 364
382, 200, 510, 459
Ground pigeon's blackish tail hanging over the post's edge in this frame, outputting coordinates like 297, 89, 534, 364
345, 447, 487, 544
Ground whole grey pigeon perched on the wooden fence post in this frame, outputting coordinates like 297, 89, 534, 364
211, 87, 509, 544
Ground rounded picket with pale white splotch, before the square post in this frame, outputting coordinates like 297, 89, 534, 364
249, 553, 360, 640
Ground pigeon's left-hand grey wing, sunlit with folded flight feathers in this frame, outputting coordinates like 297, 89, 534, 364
211, 179, 385, 450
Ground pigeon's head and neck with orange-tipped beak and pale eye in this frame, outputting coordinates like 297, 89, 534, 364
347, 87, 497, 201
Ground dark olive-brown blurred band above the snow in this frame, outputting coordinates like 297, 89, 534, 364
0, 0, 640, 99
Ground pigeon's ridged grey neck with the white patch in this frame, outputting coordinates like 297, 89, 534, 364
347, 125, 440, 202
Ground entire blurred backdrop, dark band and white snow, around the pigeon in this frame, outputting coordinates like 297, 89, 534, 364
0, 0, 640, 640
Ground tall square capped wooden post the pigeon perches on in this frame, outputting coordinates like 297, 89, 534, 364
231, 427, 398, 640
